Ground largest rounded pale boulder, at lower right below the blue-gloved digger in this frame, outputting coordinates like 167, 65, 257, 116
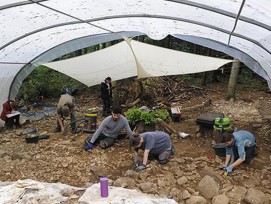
199, 175, 219, 198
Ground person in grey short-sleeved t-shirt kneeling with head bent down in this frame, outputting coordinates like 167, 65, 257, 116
130, 131, 172, 171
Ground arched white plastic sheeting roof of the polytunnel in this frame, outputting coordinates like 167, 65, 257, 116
0, 0, 271, 118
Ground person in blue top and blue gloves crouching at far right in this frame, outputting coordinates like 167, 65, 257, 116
222, 130, 256, 174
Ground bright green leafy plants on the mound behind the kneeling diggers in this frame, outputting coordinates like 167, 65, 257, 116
125, 108, 169, 125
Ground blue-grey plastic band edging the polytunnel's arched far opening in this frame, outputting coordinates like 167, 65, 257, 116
9, 32, 271, 101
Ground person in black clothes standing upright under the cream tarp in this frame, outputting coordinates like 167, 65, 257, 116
101, 77, 112, 116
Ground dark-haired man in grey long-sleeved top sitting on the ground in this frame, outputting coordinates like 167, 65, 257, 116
85, 107, 132, 150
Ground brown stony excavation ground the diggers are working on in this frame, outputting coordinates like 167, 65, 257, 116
0, 83, 271, 204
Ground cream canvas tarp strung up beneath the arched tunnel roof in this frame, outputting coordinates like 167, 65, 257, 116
44, 40, 232, 86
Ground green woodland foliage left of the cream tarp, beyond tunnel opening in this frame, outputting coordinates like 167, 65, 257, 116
17, 66, 86, 103
